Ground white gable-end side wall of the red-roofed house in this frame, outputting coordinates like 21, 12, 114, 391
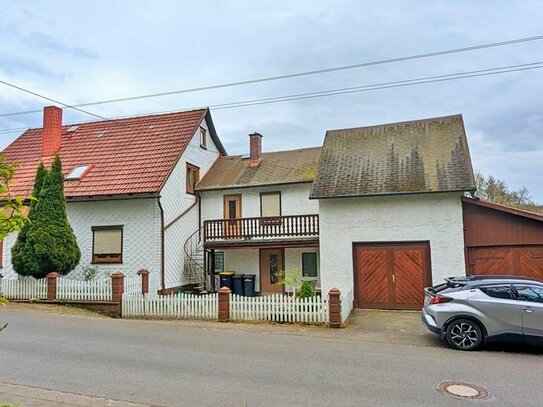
160, 115, 219, 288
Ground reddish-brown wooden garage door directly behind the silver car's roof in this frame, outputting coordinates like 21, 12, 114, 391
468, 245, 543, 280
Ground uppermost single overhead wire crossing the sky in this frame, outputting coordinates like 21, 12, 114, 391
0, 35, 543, 117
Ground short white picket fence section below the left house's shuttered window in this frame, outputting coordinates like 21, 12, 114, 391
57, 277, 111, 301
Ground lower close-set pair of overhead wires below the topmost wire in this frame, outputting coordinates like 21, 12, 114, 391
0, 61, 543, 133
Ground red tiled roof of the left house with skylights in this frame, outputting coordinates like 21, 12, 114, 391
4, 109, 226, 198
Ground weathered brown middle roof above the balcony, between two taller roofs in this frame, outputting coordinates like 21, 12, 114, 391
197, 147, 321, 190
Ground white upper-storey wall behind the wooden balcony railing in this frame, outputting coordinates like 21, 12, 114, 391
200, 182, 319, 221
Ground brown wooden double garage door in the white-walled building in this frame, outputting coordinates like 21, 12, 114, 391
353, 243, 431, 309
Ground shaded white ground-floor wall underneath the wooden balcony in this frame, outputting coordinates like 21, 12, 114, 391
217, 247, 320, 291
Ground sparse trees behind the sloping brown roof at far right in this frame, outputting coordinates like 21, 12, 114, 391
475, 172, 540, 211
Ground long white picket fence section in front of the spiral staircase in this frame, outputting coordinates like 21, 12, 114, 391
122, 293, 219, 319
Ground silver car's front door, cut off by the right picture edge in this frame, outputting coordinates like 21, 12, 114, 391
515, 285, 543, 337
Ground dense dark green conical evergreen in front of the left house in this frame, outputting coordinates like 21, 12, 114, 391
13, 155, 81, 278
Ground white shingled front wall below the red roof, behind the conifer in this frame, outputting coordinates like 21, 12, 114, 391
2, 198, 160, 278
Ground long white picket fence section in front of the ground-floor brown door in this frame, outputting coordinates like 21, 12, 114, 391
230, 294, 328, 323
